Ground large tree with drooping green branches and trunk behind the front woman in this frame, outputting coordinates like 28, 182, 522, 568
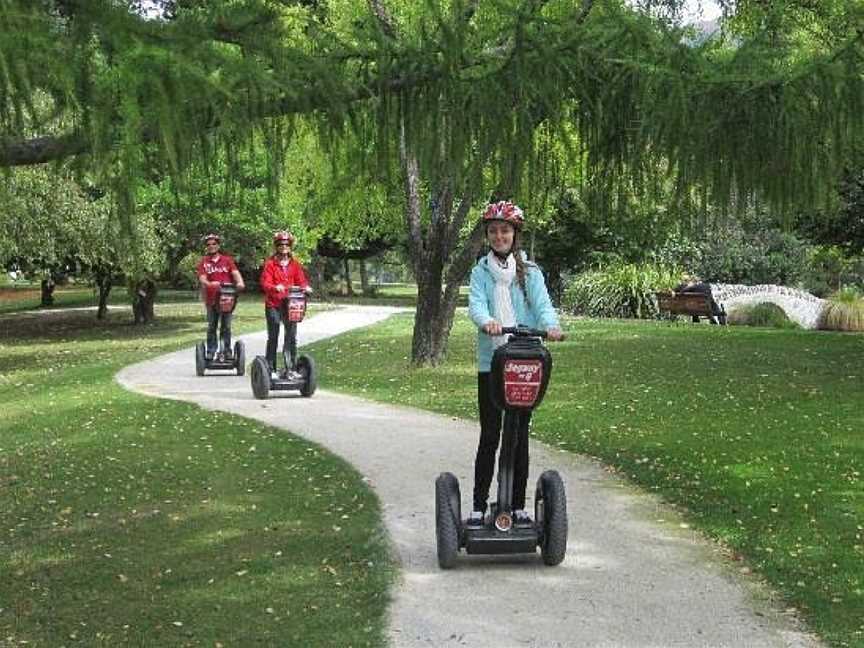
0, 0, 864, 362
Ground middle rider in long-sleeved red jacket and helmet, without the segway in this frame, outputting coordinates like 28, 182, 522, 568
260, 231, 312, 371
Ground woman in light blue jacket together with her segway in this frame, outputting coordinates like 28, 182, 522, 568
435, 202, 567, 569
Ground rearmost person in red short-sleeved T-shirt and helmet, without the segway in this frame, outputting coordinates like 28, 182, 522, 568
198, 234, 246, 359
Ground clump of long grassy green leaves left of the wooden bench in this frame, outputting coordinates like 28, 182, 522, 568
562, 263, 682, 319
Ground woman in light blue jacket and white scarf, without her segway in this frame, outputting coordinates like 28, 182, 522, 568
468, 201, 562, 526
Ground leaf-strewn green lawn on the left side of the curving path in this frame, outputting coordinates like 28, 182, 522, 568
0, 299, 395, 647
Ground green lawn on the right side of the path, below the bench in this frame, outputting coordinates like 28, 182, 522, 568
311, 315, 864, 646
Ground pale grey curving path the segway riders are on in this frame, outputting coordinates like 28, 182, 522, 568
117, 307, 820, 648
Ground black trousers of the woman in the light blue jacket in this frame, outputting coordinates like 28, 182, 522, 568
474, 371, 531, 511
